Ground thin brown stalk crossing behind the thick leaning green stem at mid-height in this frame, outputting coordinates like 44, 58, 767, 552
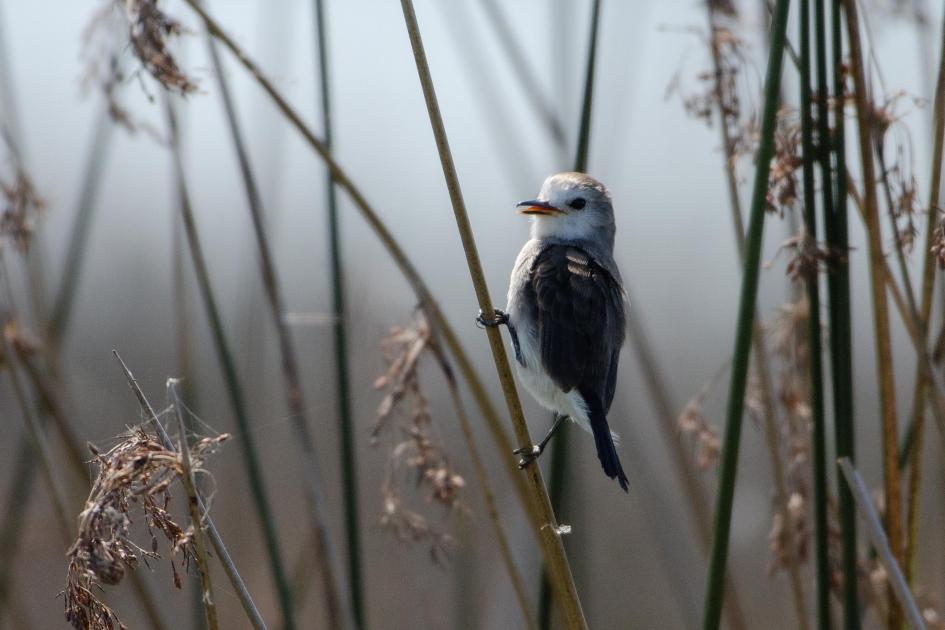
706, 7, 808, 630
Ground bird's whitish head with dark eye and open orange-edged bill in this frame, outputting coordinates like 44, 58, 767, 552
517, 173, 616, 250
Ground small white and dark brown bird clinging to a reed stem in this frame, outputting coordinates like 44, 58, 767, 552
478, 172, 629, 492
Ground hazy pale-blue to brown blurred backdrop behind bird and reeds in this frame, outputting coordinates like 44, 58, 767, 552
0, 0, 945, 628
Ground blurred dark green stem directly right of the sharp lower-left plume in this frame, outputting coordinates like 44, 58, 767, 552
164, 94, 295, 630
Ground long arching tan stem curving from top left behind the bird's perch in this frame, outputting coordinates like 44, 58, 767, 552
184, 0, 545, 535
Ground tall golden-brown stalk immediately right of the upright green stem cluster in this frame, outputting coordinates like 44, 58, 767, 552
843, 0, 903, 628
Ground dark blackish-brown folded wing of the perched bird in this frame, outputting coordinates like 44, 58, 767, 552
530, 245, 626, 413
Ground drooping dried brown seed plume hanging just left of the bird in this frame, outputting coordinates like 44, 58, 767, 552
371, 315, 466, 563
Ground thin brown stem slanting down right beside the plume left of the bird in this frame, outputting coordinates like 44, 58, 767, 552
432, 330, 538, 630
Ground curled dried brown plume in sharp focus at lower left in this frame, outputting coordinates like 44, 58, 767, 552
64, 427, 229, 630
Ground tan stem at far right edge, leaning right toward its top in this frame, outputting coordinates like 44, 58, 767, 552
900, 3, 945, 583
